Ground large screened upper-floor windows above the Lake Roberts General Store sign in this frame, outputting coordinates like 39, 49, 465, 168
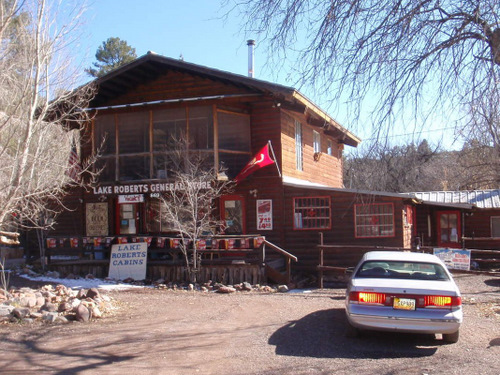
94, 106, 215, 182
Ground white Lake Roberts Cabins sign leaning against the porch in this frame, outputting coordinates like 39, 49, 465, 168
109, 242, 148, 280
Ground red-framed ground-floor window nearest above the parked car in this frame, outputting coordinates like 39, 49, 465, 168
354, 203, 395, 238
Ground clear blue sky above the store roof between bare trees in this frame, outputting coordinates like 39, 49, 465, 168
71, 0, 456, 151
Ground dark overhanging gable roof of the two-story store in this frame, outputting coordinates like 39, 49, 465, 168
89, 52, 361, 147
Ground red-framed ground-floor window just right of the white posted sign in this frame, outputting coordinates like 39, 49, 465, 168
293, 197, 331, 230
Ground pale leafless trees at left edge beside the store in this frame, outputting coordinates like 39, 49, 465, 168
0, 0, 95, 245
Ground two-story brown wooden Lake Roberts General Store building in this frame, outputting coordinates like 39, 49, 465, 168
37, 53, 424, 282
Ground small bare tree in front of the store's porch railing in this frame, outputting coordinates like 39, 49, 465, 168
159, 137, 234, 282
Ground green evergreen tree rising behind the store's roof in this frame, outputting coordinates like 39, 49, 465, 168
85, 38, 137, 78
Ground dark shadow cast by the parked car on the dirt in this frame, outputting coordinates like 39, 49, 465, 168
268, 309, 441, 359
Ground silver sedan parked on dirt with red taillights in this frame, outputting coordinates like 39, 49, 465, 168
346, 251, 463, 342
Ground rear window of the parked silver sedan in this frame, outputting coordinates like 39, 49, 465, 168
355, 261, 449, 280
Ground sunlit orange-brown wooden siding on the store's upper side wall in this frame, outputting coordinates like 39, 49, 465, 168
281, 111, 343, 188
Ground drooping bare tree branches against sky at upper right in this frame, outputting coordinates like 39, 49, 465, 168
229, 0, 500, 156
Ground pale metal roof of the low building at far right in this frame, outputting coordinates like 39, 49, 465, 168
410, 189, 500, 208
